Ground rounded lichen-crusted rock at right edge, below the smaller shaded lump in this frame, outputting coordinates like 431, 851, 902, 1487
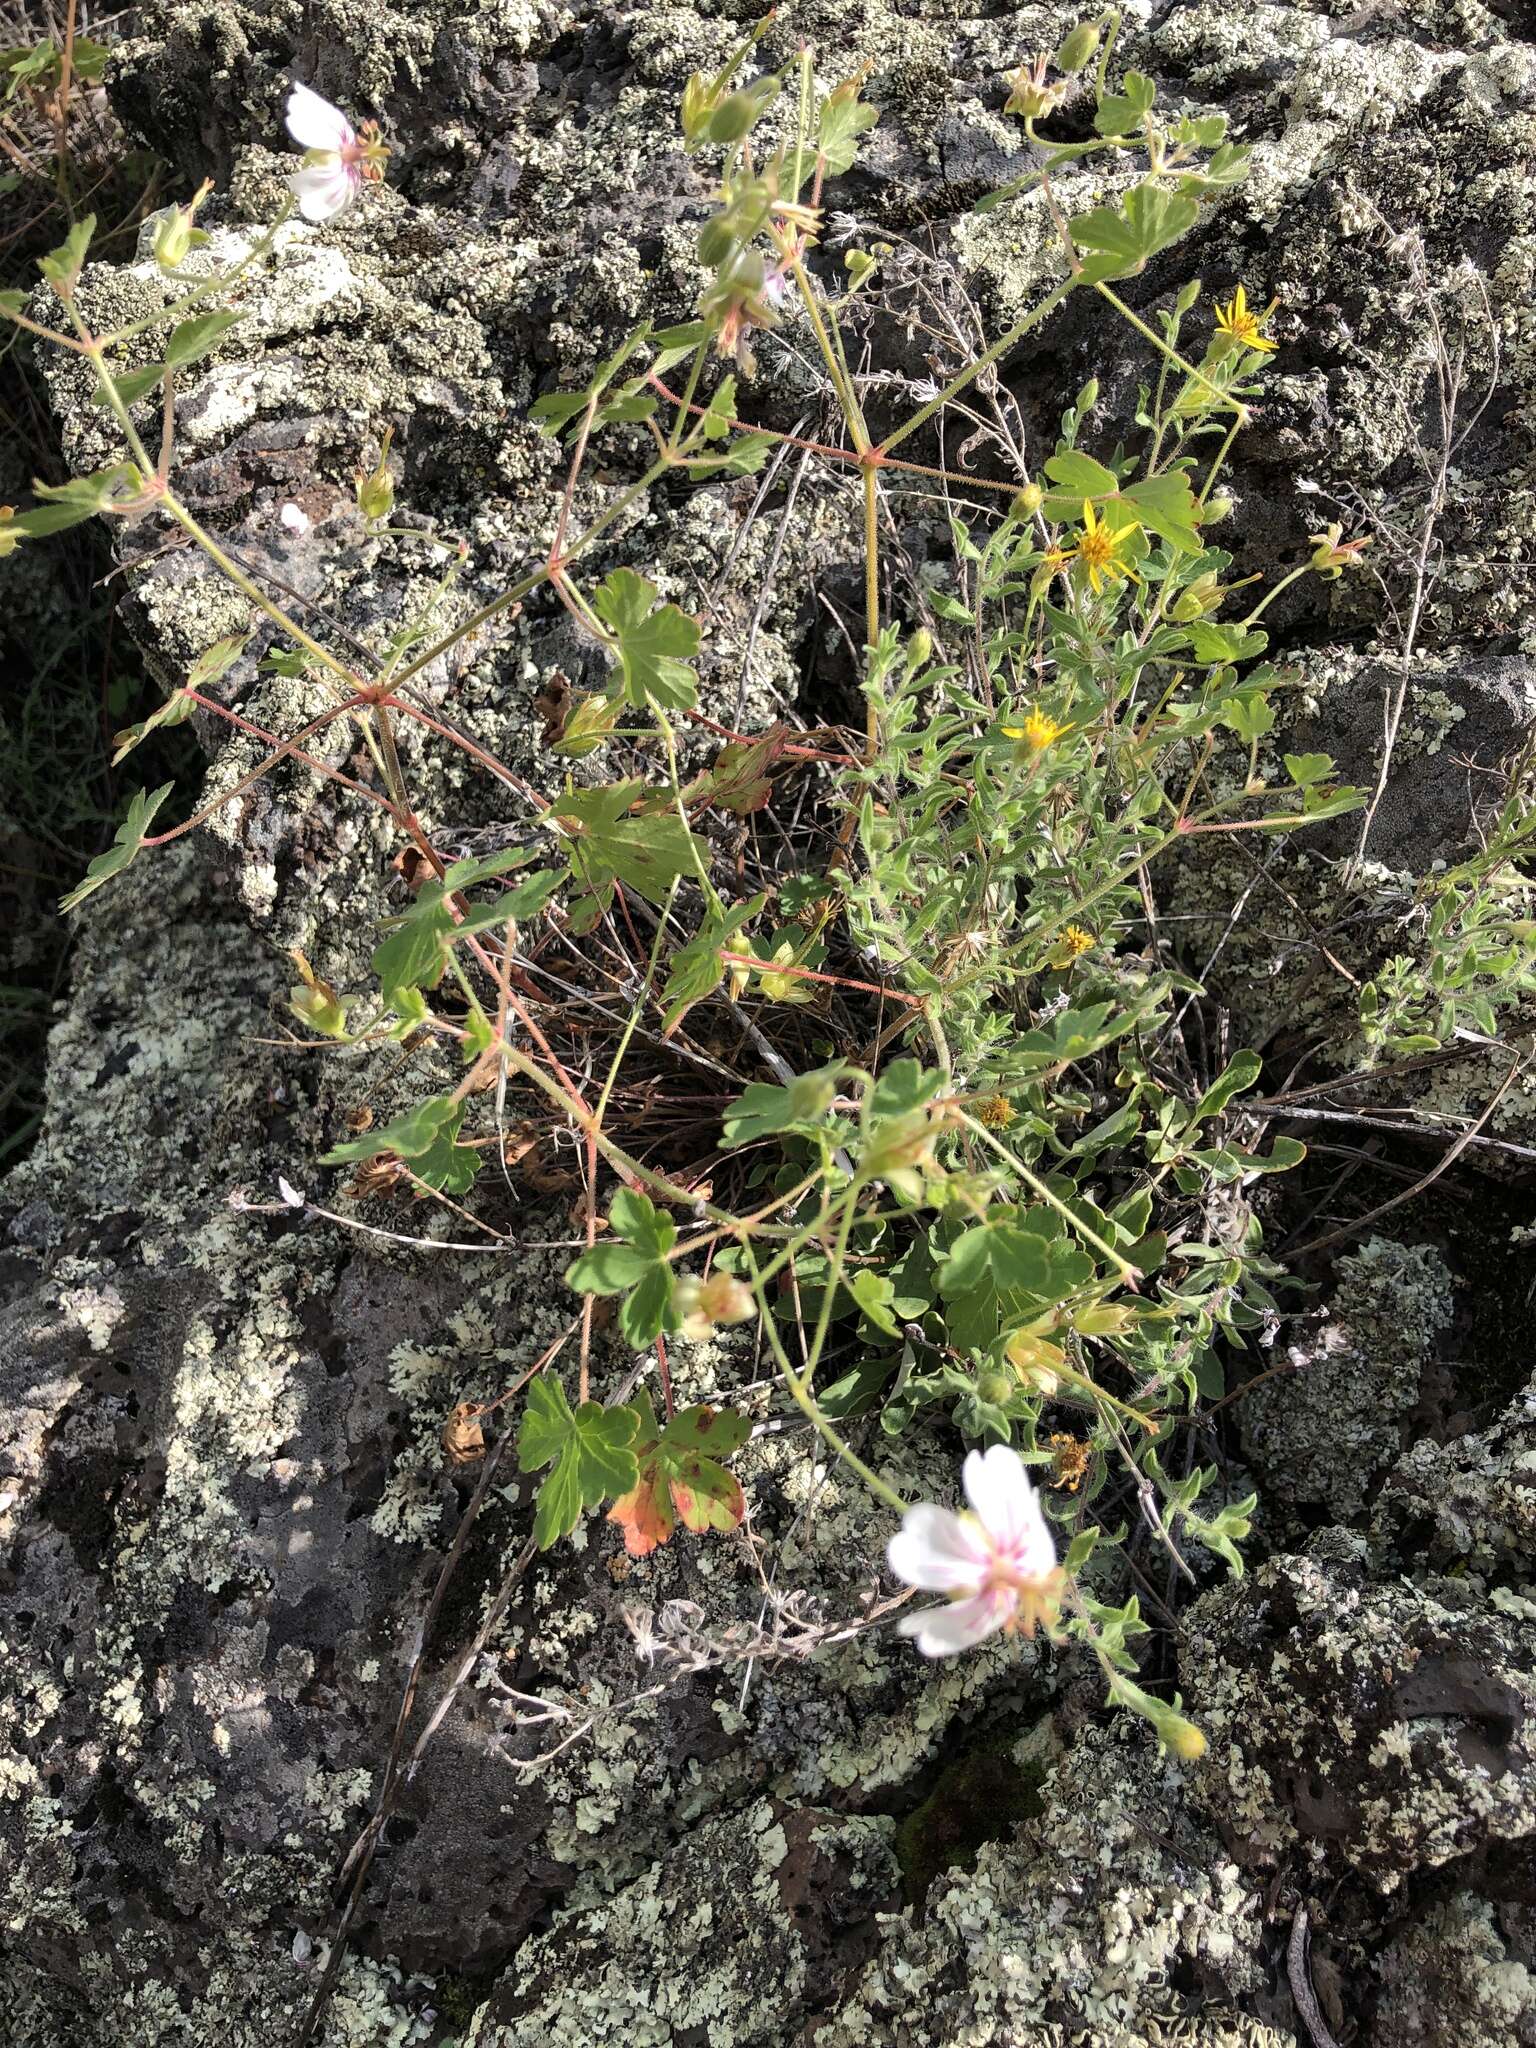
1186, 1530, 1536, 1890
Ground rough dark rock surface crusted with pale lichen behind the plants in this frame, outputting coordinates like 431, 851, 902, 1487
0, 0, 1536, 2048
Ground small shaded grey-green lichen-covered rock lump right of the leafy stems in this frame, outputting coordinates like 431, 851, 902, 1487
1241, 1237, 1452, 1522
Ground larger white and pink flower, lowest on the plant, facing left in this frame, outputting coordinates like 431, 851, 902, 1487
885, 1444, 1063, 1657
